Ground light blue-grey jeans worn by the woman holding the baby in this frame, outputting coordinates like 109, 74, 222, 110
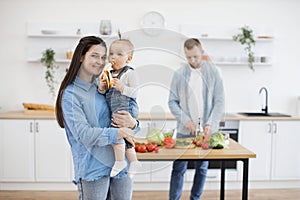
77, 176, 132, 200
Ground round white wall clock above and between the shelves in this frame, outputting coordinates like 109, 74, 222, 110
141, 11, 165, 36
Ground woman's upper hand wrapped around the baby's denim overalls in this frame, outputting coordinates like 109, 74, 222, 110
111, 110, 137, 129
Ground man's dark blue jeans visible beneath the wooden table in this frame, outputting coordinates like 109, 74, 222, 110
169, 160, 208, 200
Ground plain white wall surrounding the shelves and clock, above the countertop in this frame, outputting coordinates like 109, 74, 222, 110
0, 0, 300, 115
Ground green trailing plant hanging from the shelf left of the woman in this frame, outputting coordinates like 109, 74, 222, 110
41, 48, 58, 99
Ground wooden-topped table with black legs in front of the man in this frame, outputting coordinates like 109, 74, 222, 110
137, 139, 256, 200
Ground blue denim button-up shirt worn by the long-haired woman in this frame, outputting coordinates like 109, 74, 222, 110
62, 77, 127, 183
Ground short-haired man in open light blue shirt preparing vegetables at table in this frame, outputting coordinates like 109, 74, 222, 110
169, 38, 224, 200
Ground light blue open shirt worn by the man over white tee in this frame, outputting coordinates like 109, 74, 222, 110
168, 61, 225, 135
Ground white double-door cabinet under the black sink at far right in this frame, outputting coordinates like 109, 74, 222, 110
240, 120, 300, 180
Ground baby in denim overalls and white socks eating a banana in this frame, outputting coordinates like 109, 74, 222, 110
98, 39, 141, 178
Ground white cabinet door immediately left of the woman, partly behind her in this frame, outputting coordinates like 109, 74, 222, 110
35, 120, 71, 182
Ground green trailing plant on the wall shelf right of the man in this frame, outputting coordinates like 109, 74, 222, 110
232, 25, 255, 71
